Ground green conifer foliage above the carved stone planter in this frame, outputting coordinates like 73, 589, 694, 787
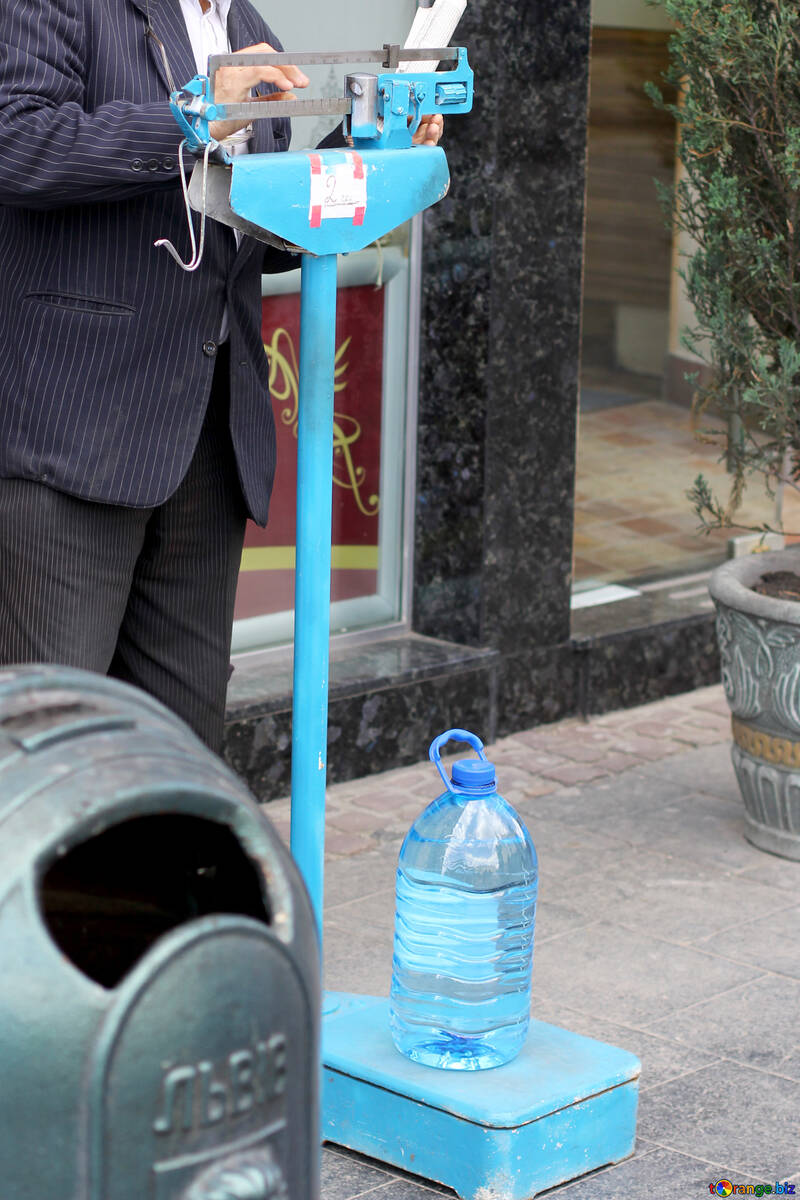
648, 0, 800, 528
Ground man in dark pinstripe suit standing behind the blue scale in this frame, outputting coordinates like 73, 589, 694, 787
0, 0, 440, 750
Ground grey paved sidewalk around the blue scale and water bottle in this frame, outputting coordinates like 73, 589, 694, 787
266, 688, 800, 1200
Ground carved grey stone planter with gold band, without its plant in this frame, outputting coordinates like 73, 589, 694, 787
709, 546, 800, 860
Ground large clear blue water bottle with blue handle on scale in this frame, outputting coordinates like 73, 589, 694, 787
390, 730, 539, 1070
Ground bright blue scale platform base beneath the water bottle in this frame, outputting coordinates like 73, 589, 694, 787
323, 992, 640, 1200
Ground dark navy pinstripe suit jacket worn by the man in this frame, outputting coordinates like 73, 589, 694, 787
0, 0, 294, 523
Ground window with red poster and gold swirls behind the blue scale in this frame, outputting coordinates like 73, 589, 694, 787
233, 0, 419, 653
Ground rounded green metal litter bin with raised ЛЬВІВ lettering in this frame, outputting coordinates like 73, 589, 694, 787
0, 667, 319, 1200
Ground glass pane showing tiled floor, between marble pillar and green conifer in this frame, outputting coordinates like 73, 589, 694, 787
573, 0, 786, 599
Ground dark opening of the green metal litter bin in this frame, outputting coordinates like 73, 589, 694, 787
40, 814, 270, 988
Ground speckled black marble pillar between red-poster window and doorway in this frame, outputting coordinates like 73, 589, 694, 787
414, 0, 589, 672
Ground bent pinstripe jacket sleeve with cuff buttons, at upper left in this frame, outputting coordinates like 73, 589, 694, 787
0, 0, 181, 209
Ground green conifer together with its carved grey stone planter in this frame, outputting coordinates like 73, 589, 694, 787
649, 0, 800, 860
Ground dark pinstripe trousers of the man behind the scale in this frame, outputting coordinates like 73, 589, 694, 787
0, 343, 247, 752
